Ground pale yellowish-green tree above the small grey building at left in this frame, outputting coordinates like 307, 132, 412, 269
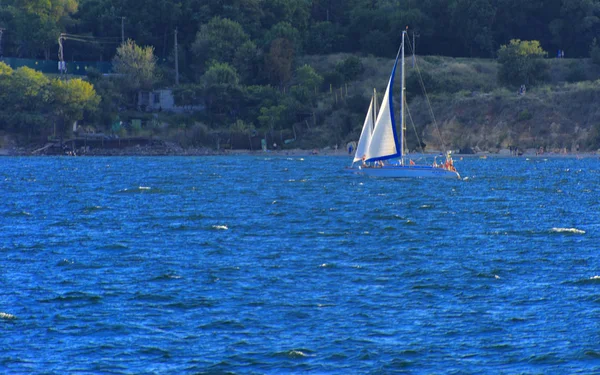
113, 39, 158, 104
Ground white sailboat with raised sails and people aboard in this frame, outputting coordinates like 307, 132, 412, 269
351, 30, 460, 178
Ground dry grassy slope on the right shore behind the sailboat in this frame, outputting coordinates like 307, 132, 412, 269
302, 54, 600, 152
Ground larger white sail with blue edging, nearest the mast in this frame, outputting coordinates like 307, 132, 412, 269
366, 74, 399, 161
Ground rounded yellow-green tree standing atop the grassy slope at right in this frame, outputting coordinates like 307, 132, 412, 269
498, 39, 548, 85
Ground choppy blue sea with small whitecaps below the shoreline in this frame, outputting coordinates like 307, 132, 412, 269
0, 154, 600, 374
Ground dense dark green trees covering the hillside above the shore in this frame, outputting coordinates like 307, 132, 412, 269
0, 0, 600, 150
